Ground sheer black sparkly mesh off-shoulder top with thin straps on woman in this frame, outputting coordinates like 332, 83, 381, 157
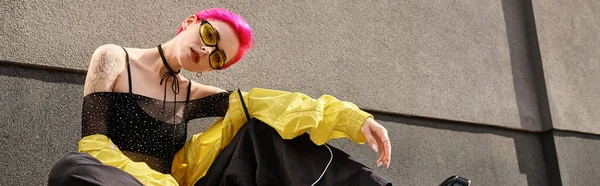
82, 48, 231, 174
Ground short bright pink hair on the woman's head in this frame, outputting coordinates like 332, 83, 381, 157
177, 8, 254, 69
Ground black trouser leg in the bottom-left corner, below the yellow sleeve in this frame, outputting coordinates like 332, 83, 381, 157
48, 152, 143, 186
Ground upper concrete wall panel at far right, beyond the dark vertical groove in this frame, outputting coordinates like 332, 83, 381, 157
532, 0, 600, 134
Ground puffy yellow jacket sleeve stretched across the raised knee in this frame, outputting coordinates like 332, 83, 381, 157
238, 88, 373, 145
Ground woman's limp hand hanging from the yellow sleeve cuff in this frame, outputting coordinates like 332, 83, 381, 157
360, 117, 392, 167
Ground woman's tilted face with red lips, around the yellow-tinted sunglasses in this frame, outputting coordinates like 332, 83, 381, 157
176, 16, 240, 72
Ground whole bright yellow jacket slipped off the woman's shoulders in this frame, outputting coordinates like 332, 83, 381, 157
79, 88, 373, 185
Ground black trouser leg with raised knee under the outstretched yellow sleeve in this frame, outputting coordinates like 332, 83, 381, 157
195, 119, 392, 186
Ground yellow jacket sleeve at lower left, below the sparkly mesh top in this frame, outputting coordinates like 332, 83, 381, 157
79, 134, 178, 186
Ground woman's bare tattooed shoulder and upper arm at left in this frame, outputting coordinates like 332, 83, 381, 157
84, 44, 125, 95
